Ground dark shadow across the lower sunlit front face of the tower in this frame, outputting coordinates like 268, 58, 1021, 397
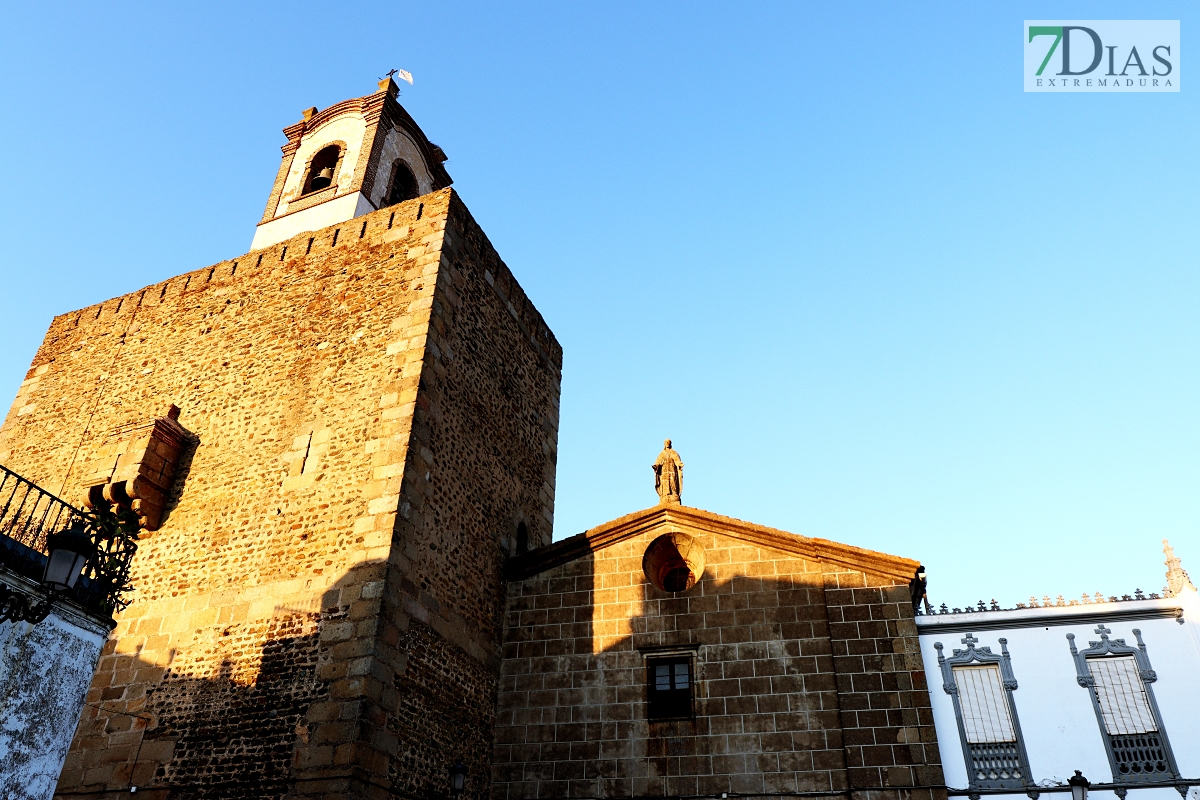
55, 571, 352, 800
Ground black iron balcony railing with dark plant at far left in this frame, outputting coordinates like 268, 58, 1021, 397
0, 465, 137, 615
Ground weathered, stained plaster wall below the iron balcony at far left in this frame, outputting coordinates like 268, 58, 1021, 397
0, 614, 107, 800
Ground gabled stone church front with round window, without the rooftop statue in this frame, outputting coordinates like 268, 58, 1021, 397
492, 503, 943, 799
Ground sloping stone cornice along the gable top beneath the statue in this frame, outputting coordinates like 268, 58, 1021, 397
506, 505, 919, 582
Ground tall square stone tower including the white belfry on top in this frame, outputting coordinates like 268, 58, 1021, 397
0, 79, 562, 800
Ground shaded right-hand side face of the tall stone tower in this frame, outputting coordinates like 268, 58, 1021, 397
374, 190, 562, 798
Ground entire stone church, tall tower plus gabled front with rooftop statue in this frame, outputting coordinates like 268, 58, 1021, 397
0, 79, 944, 800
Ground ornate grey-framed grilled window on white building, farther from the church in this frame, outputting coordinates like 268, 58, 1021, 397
1067, 625, 1180, 784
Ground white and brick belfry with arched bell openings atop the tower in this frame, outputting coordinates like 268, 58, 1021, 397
250, 77, 452, 251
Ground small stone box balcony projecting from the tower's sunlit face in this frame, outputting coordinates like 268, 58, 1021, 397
85, 404, 196, 531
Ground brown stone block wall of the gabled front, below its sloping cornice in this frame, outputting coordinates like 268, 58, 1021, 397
492, 529, 942, 800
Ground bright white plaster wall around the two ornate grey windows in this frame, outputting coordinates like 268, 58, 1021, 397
919, 593, 1200, 800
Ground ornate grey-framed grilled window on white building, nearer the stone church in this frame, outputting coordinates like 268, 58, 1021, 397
934, 633, 1033, 789
